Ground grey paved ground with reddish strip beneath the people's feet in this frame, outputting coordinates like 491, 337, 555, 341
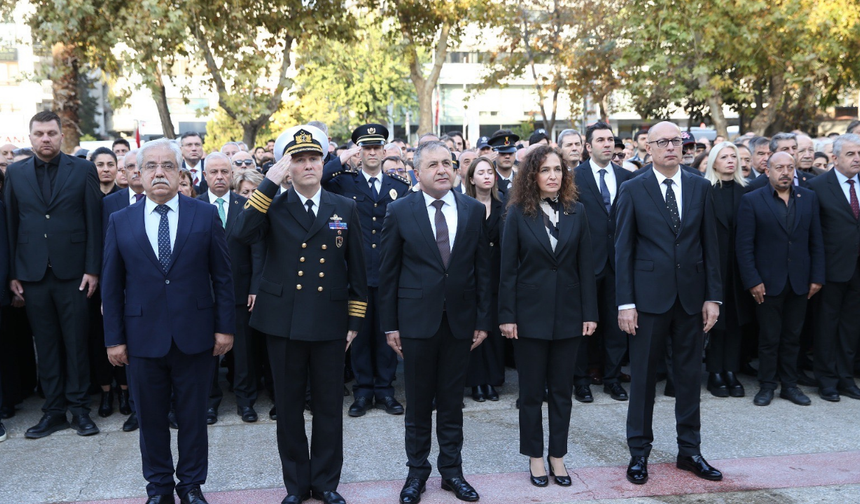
0, 364, 860, 504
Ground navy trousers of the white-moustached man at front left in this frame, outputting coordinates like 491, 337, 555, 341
128, 343, 215, 497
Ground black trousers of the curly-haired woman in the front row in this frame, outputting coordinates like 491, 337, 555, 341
514, 338, 583, 458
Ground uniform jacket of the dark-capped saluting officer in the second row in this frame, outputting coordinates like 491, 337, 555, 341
322, 157, 409, 287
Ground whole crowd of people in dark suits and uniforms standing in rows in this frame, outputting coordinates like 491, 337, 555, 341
0, 112, 860, 504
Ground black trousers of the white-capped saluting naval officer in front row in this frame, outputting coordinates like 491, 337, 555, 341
267, 334, 346, 496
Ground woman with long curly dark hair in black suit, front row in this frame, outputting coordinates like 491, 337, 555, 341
499, 146, 596, 486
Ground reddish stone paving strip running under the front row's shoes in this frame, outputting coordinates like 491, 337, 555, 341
67, 451, 860, 504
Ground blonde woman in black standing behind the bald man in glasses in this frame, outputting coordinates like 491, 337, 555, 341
705, 142, 753, 397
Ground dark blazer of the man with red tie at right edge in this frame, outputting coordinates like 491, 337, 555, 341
809, 168, 860, 282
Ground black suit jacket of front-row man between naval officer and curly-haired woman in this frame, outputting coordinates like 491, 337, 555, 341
379, 191, 493, 339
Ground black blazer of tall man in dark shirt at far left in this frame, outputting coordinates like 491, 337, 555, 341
3, 153, 104, 282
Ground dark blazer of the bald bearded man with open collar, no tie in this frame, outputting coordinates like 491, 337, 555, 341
735, 184, 824, 296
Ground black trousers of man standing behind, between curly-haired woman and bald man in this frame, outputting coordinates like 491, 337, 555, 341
575, 266, 627, 386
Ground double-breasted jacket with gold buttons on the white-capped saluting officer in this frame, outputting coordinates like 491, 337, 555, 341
232, 179, 367, 341
